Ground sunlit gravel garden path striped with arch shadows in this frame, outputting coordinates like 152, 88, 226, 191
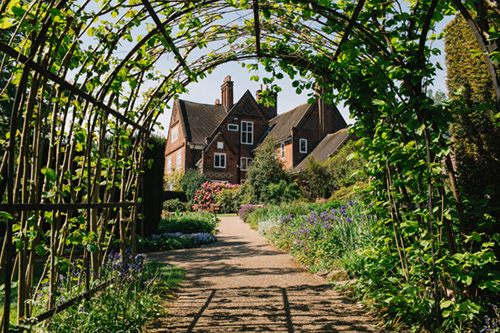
148, 217, 380, 333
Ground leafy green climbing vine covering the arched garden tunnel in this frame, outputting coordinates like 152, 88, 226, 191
0, 0, 500, 330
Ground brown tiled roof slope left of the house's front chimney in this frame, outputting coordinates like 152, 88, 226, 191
178, 100, 226, 144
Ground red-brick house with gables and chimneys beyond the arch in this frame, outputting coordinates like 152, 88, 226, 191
165, 76, 347, 184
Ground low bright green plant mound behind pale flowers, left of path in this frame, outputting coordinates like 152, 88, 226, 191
155, 212, 217, 234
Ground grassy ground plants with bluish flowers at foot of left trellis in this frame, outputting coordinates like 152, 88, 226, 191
11, 249, 184, 333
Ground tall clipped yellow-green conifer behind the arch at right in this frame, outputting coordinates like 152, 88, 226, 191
445, 15, 500, 223
